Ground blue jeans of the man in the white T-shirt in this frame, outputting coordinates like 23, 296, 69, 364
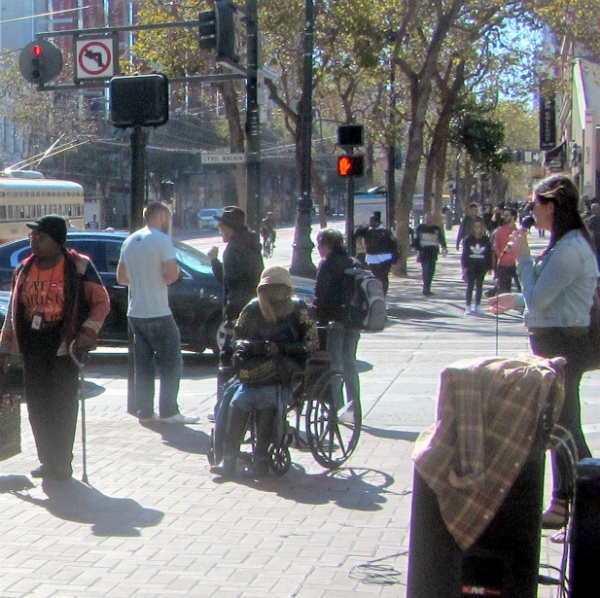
129, 316, 183, 418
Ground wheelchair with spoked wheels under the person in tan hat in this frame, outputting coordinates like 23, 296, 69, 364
207, 351, 362, 476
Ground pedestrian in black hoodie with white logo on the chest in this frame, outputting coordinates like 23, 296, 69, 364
461, 218, 492, 316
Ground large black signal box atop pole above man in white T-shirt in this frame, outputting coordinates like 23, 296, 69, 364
110, 73, 169, 129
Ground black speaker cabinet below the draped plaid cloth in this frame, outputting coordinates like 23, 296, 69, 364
407, 450, 544, 598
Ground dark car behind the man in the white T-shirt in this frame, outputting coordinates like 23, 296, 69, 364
0, 231, 314, 354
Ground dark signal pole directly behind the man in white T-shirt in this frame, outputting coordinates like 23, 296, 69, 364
127, 125, 146, 415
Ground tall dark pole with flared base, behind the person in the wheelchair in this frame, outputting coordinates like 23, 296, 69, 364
290, 0, 317, 278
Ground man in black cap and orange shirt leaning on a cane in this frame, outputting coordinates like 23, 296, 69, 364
0, 214, 110, 480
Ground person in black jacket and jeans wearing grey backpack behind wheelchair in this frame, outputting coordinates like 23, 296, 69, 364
315, 228, 360, 408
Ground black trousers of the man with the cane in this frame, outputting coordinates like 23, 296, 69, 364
23, 353, 79, 469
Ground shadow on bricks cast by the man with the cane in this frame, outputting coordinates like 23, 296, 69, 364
11, 476, 164, 537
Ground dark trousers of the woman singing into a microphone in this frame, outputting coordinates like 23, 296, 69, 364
529, 328, 592, 499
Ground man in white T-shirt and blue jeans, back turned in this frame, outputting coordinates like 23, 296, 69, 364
117, 202, 200, 424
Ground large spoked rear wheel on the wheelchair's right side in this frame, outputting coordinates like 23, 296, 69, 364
306, 371, 362, 469
